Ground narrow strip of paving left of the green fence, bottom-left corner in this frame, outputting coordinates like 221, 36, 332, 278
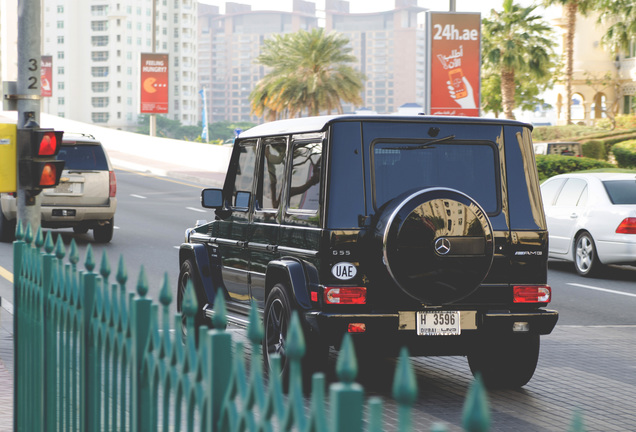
0, 299, 13, 432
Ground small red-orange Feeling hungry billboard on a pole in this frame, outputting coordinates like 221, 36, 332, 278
140, 53, 168, 114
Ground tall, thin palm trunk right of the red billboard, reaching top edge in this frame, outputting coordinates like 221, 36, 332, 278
543, 0, 596, 124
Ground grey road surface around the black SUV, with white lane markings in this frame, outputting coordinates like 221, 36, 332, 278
0, 170, 636, 431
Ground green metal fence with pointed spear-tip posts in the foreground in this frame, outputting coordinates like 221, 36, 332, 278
14, 226, 580, 432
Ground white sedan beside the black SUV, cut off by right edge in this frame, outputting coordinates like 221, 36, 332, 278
541, 173, 636, 276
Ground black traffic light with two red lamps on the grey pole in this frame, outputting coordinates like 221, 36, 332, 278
18, 128, 64, 190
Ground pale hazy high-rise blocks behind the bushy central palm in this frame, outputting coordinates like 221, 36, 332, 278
198, 0, 426, 122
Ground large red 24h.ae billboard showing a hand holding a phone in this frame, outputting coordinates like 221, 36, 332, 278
426, 12, 481, 117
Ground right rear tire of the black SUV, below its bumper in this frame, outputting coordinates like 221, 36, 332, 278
468, 334, 540, 388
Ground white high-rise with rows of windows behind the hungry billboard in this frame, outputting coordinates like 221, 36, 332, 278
42, 0, 200, 130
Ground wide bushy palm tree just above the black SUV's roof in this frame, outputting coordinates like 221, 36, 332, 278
250, 29, 364, 120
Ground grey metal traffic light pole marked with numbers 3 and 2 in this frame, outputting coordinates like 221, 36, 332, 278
16, 0, 42, 229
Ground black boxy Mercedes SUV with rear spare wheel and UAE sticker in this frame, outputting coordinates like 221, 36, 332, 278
177, 115, 558, 387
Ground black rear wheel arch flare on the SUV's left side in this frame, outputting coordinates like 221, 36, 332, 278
265, 258, 318, 309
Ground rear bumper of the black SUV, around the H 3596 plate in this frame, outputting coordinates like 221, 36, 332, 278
305, 309, 559, 355
